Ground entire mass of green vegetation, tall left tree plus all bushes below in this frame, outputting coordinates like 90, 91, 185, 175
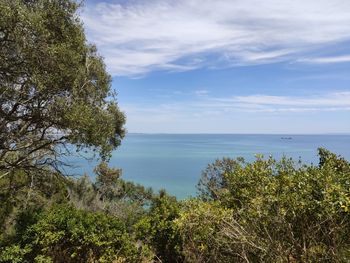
0, 0, 350, 262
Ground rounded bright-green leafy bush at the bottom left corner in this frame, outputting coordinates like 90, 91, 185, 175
2, 205, 148, 262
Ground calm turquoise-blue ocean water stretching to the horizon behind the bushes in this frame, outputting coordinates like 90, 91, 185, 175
71, 134, 350, 199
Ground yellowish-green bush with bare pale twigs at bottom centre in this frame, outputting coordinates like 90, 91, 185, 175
176, 200, 268, 262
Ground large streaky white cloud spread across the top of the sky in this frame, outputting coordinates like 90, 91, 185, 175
82, 0, 350, 75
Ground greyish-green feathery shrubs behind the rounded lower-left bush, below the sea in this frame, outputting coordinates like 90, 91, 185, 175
68, 163, 154, 226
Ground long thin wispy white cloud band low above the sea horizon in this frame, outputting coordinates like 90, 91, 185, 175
121, 92, 350, 119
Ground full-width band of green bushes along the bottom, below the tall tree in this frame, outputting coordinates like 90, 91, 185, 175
0, 149, 350, 262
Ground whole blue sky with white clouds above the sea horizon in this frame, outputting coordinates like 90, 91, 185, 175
79, 0, 350, 134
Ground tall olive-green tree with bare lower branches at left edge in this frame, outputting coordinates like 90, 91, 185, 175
0, 0, 125, 176
